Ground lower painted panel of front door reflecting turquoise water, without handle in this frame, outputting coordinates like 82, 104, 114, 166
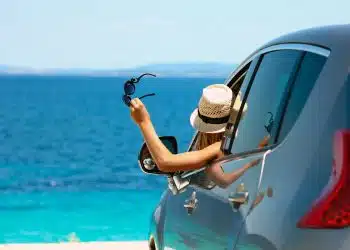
164, 186, 234, 250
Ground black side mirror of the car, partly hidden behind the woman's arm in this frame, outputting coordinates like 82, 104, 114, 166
138, 136, 178, 175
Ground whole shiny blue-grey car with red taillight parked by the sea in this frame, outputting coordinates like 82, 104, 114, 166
139, 25, 350, 250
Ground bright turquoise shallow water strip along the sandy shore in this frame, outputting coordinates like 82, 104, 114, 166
1, 190, 161, 243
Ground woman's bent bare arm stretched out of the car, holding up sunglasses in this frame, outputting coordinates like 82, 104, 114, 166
130, 98, 221, 172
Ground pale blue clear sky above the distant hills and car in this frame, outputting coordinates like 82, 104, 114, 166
0, 0, 350, 69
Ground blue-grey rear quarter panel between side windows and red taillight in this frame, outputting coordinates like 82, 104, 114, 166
236, 26, 350, 250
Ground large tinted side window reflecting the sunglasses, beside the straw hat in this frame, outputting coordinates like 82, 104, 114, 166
231, 50, 302, 153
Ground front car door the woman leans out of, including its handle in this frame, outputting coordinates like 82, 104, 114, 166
164, 60, 258, 250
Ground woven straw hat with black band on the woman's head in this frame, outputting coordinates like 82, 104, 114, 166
190, 84, 247, 133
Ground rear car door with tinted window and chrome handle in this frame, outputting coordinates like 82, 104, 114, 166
222, 49, 304, 249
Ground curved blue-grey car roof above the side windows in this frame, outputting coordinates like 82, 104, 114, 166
257, 24, 350, 51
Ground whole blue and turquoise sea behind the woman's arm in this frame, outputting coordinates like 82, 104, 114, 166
0, 75, 224, 244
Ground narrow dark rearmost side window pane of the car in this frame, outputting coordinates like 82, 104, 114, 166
279, 52, 327, 140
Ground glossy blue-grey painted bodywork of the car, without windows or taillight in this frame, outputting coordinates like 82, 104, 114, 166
151, 25, 350, 250
